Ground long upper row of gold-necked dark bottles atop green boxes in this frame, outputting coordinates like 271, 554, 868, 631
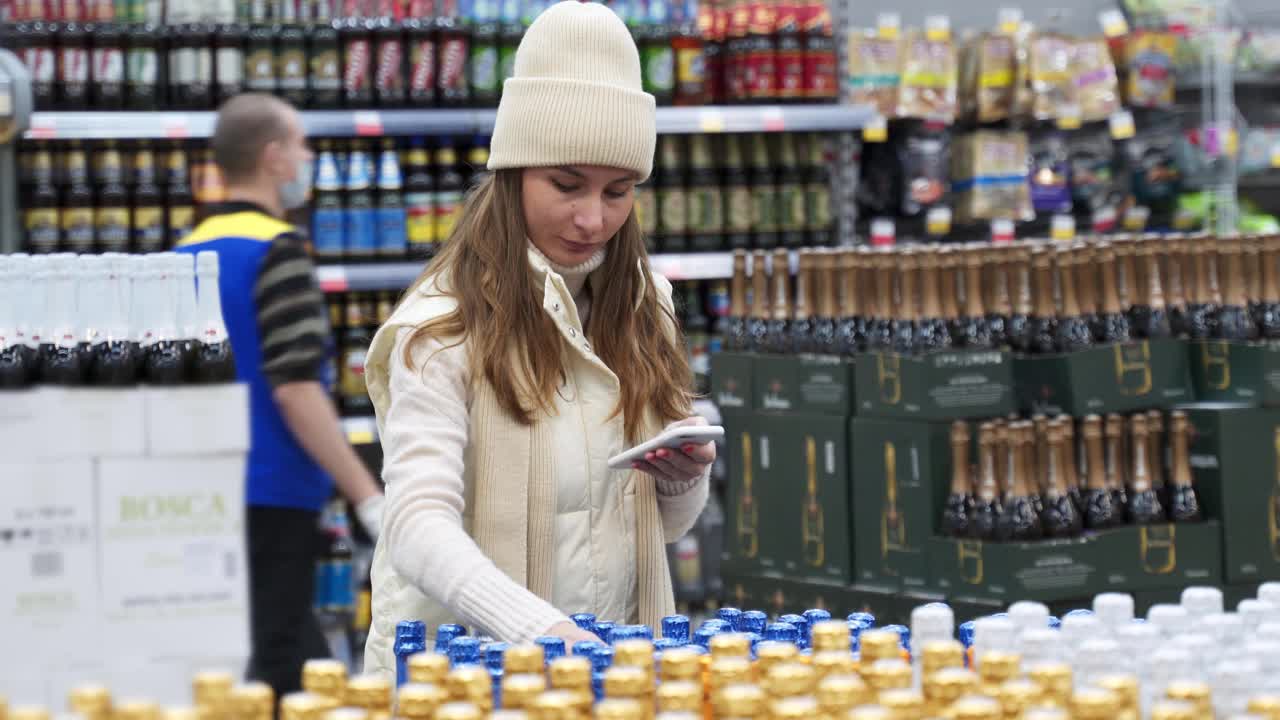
726, 234, 1280, 355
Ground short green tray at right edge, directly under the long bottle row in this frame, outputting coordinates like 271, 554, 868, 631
1187, 340, 1280, 407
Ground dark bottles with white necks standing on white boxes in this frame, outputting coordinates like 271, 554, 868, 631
0, 251, 236, 388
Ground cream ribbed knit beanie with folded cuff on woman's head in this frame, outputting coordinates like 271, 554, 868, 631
489, 0, 657, 179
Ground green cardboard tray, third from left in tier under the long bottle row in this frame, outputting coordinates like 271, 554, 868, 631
855, 350, 1015, 420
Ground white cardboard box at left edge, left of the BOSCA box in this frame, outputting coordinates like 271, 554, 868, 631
0, 460, 101, 666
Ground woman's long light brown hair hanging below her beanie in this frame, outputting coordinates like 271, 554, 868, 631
404, 169, 692, 442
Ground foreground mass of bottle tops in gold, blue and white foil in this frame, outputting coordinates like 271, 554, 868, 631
17, 583, 1280, 720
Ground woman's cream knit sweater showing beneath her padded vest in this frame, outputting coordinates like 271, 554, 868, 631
375, 240, 709, 642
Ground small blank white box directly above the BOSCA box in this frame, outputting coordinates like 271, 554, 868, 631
143, 383, 250, 457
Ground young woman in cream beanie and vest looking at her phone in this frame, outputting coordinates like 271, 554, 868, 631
365, 0, 716, 671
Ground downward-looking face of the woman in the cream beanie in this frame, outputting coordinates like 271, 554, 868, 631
521, 165, 637, 268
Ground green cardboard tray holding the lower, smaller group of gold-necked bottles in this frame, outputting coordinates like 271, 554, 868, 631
928, 520, 1222, 602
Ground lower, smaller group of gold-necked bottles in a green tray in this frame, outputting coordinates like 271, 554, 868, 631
941, 410, 1202, 542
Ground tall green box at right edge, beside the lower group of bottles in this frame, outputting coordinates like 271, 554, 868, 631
1181, 404, 1280, 583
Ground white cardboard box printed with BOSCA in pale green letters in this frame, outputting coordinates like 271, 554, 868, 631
97, 454, 248, 659
